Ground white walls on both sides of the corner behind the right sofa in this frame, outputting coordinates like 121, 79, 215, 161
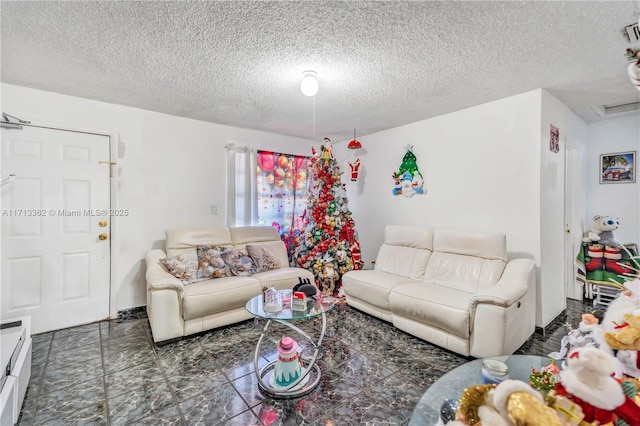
335, 90, 596, 326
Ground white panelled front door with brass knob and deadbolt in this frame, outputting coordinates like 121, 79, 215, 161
0, 125, 111, 333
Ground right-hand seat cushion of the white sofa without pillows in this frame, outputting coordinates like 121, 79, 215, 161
389, 282, 473, 339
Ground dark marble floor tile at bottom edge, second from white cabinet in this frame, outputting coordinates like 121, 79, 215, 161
109, 382, 175, 425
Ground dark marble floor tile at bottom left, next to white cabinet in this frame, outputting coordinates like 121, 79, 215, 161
34, 377, 106, 424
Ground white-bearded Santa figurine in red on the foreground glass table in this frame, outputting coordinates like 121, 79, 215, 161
555, 346, 640, 426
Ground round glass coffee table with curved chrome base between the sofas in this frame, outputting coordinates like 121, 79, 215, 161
246, 294, 335, 398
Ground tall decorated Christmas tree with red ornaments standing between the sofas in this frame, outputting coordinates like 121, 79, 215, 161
296, 138, 362, 296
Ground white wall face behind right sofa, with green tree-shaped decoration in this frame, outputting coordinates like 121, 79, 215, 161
334, 90, 541, 306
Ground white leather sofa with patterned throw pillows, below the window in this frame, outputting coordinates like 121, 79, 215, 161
146, 226, 314, 342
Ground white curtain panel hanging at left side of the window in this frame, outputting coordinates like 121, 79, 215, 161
225, 144, 258, 226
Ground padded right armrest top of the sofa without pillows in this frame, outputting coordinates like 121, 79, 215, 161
469, 259, 535, 310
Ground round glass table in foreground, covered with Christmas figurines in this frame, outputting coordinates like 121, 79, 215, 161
409, 355, 551, 426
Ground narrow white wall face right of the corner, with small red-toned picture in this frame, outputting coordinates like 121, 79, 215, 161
536, 90, 586, 326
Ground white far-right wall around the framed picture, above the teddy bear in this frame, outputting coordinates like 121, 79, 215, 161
584, 115, 640, 244
